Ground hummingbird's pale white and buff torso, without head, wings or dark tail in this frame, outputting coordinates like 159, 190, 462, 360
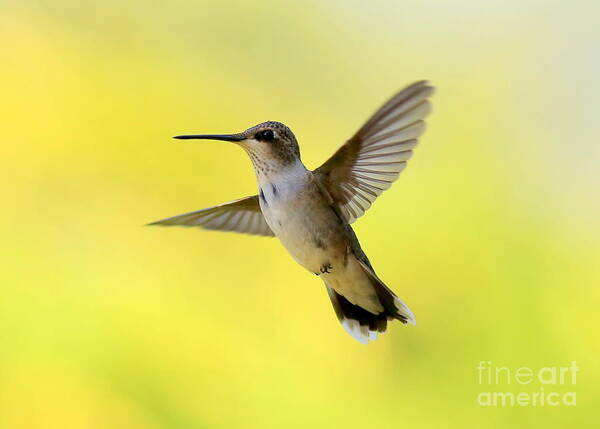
259, 162, 383, 313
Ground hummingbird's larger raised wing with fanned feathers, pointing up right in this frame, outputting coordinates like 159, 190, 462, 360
315, 81, 433, 223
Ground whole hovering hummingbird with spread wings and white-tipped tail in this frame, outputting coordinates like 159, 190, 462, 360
150, 81, 434, 343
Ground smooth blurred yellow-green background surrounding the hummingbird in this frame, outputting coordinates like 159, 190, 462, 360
0, 0, 600, 429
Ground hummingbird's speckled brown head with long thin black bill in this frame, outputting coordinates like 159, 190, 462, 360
175, 121, 300, 175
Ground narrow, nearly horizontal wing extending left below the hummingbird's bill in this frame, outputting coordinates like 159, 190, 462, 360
149, 195, 275, 237
